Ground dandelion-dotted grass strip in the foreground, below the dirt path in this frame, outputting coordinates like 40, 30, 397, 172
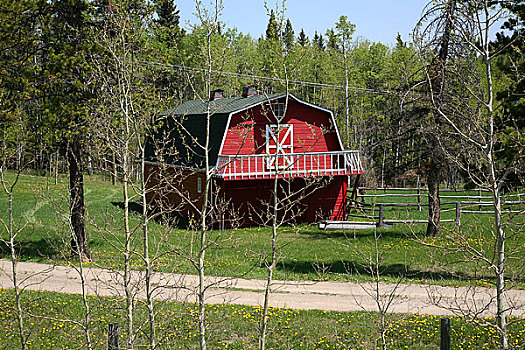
0, 290, 525, 350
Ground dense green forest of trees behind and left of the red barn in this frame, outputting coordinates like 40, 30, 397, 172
0, 0, 523, 227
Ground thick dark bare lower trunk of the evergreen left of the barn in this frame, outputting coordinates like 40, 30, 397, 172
68, 138, 91, 260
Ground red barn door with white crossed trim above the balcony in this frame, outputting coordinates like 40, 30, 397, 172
266, 124, 293, 169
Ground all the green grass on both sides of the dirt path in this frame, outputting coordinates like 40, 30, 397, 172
0, 175, 525, 350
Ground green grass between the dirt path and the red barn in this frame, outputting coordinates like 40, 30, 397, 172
0, 175, 525, 286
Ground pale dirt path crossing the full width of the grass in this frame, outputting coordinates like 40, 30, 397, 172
0, 260, 525, 317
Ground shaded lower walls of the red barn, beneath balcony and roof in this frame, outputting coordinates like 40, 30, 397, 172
145, 164, 347, 226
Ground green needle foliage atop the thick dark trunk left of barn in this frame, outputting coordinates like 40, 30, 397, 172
39, 0, 96, 148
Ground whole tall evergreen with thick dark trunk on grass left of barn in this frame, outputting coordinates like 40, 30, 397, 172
42, 0, 94, 259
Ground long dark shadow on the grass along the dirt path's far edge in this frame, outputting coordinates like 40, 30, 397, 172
276, 260, 484, 281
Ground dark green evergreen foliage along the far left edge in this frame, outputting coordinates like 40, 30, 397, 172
0, 0, 45, 168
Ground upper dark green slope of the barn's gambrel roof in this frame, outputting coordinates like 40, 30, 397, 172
162, 94, 285, 115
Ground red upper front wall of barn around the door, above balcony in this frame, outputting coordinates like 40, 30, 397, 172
222, 99, 341, 155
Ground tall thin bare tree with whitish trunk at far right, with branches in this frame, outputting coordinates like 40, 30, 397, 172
414, 0, 521, 350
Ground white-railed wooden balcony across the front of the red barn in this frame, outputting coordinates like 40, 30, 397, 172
214, 151, 363, 180
